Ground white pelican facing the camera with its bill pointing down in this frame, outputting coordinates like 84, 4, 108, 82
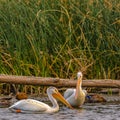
64, 72, 86, 107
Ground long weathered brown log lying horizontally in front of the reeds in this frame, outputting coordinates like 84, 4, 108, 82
0, 75, 120, 88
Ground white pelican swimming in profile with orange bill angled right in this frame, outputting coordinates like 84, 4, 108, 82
9, 87, 72, 113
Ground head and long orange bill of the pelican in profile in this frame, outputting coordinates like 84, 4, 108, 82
47, 87, 73, 109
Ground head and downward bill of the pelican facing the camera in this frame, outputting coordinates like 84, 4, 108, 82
75, 72, 83, 99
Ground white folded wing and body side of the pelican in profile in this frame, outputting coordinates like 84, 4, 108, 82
9, 99, 49, 112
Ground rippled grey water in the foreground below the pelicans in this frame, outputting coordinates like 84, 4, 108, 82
0, 102, 120, 120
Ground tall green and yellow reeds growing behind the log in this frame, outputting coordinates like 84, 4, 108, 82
0, 0, 120, 93
